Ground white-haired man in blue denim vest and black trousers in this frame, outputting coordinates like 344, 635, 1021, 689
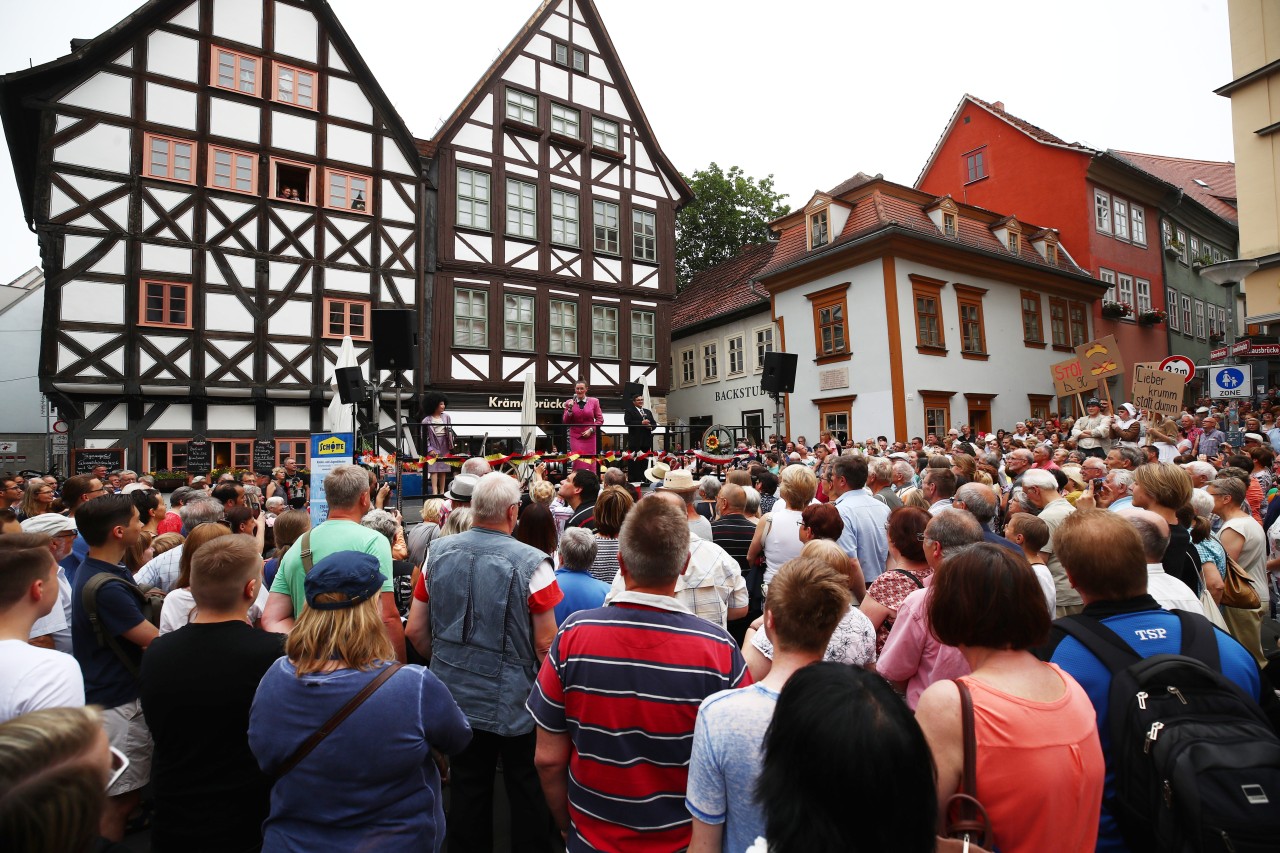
415, 473, 568, 850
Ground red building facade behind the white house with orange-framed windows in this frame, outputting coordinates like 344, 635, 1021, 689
916, 95, 1169, 402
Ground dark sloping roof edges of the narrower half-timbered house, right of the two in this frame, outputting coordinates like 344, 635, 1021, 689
419, 0, 694, 205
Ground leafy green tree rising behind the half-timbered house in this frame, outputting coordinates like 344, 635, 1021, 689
676, 163, 791, 287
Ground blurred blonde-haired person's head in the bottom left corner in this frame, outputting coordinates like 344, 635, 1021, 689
0, 707, 119, 853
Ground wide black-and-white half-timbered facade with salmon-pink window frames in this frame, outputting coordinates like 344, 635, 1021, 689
0, 0, 434, 470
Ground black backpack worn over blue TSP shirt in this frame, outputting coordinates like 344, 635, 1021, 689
1055, 611, 1280, 853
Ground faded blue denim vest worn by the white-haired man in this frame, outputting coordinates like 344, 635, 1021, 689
426, 528, 548, 736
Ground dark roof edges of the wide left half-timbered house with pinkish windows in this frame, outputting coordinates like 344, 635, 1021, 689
0, 0, 430, 220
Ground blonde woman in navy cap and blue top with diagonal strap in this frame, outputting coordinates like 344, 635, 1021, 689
248, 551, 471, 852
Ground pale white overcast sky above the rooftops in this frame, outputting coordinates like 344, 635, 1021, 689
0, 0, 1234, 282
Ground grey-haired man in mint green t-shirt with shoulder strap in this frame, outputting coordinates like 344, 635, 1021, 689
266, 465, 404, 661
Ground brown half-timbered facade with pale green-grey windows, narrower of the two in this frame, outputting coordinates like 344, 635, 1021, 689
431, 0, 691, 419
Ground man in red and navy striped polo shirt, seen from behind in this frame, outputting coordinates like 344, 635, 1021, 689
529, 494, 748, 850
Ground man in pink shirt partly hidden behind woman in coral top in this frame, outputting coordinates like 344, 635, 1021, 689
876, 511, 982, 711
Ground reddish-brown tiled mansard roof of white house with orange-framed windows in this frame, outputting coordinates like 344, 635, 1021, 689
755, 178, 1100, 283
